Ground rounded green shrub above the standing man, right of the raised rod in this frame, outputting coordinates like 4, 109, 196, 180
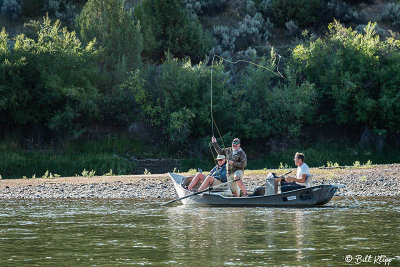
232, 56, 316, 140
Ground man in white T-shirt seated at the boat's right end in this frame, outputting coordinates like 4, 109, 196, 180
275, 152, 312, 194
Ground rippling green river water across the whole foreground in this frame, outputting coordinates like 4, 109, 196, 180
0, 197, 400, 266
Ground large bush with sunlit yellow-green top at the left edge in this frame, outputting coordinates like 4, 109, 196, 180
0, 17, 99, 135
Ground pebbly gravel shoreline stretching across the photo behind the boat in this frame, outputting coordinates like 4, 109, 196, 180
0, 164, 400, 200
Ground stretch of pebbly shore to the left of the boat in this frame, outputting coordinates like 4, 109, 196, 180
0, 175, 176, 199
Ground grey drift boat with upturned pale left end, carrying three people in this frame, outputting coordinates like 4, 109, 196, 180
168, 173, 343, 207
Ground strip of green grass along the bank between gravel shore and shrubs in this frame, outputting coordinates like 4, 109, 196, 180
0, 135, 400, 179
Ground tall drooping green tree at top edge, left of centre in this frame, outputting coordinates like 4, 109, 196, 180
76, 0, 143, 88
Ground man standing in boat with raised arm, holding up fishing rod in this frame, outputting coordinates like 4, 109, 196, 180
211, 136, 247, 197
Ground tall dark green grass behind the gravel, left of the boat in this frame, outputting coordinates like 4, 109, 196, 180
0, 135, 142, 178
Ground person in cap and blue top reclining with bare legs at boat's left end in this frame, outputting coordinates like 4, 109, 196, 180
188, 155, 227, 191
